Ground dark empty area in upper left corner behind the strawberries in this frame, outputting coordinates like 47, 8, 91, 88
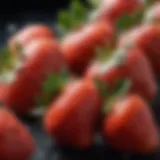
0, 0, 73, 44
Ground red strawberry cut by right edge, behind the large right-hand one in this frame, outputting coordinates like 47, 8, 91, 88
119, 24, 160, 77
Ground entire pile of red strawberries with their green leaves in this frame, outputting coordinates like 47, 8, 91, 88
0, 0, 160, 160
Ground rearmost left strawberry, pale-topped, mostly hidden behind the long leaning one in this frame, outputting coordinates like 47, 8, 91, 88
8, 24, 54, 55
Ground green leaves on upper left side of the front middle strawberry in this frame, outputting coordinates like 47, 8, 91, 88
35, 70, 69, 106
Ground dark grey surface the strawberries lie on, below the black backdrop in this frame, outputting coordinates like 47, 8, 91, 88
0, 13, 160, 160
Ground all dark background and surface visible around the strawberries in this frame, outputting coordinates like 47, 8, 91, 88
0, 0, 160, 160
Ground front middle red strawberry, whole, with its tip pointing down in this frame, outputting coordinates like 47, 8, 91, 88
44, 80, 101, 149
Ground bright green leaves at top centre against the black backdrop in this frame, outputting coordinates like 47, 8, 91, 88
58, 0, 100, 35
